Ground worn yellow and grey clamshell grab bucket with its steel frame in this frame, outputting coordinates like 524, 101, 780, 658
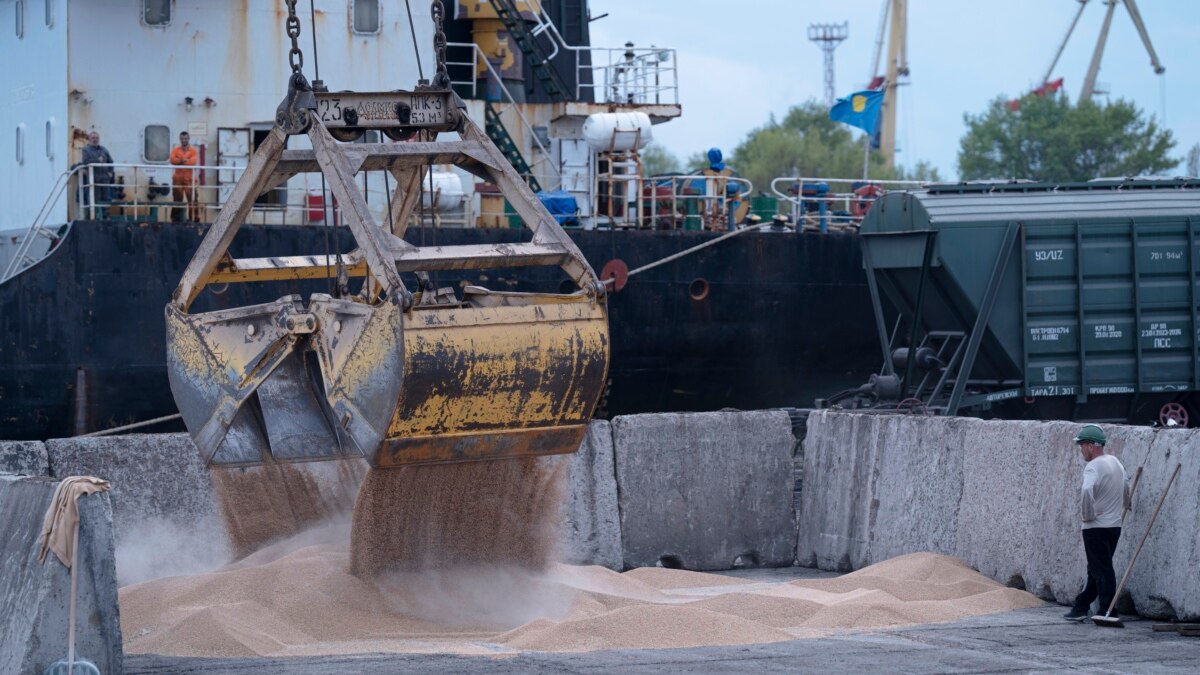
166, 77, 608, 468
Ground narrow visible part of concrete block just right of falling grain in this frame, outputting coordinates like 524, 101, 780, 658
560, 419, 622, 571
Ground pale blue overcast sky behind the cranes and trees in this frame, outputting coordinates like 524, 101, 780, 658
590, 0, 1200, 178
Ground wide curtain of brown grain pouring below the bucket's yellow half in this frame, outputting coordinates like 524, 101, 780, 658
350, 458, 566, 577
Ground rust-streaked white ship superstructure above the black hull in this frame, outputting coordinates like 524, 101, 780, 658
0, 0, 696, 275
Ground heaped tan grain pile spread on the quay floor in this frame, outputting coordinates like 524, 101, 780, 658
121, 540, 1042, 656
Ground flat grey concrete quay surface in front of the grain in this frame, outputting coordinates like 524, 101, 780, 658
125, 605, 1200, 675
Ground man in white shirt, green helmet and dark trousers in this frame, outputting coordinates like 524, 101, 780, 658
1064, 424, 1129, 621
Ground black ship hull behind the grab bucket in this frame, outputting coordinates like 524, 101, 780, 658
0, 221, 878, 440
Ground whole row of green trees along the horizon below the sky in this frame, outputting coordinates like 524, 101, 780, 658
642, 92, 1185, 190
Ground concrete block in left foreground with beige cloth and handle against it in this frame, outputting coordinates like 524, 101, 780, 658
0, 476, 124, 673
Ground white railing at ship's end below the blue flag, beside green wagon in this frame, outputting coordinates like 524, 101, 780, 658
770, 175, 929, 232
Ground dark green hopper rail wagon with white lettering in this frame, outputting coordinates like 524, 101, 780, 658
835, 179, 1200, 425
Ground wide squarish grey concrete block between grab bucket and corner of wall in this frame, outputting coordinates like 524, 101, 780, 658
612, 411, 796, 569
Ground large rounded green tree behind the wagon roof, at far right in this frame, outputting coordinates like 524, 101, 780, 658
959, 94, 1180, 183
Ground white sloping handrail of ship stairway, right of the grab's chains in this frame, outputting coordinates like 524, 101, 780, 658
446, 42, 563, 190
